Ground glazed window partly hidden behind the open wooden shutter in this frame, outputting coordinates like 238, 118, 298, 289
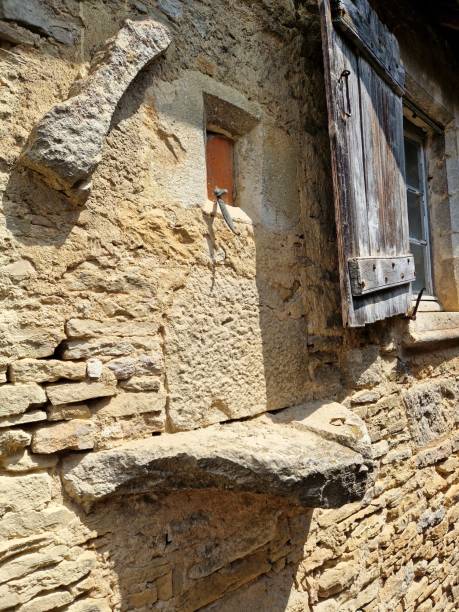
404, 120, 433, 296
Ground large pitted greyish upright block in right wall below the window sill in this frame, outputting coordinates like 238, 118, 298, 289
403, 381, 455, 446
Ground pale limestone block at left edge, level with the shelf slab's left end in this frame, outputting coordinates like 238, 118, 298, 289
0, 474, 51, 516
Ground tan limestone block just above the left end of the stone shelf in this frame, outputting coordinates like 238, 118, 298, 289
32, 419, 95, 454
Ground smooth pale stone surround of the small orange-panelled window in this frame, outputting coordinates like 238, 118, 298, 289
151, 70, 300, 231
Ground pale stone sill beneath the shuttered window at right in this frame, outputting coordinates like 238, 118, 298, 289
402, 312, 459, 348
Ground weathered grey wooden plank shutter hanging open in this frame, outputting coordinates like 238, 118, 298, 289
320, 0, 415, 327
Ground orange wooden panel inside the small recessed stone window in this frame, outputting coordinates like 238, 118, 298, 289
206, 133, 234, 204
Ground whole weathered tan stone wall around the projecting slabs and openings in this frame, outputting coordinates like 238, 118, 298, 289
0, 0, 459, 612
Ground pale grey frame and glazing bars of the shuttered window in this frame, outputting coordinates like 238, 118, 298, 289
403, 116, 438, 302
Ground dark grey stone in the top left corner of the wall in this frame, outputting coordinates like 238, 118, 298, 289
0, 0, 78, 45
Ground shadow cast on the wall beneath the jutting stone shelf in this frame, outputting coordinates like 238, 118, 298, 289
77, 491, 312, 612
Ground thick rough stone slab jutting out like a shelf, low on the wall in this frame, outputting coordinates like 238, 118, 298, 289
62, 402, 373, 510
